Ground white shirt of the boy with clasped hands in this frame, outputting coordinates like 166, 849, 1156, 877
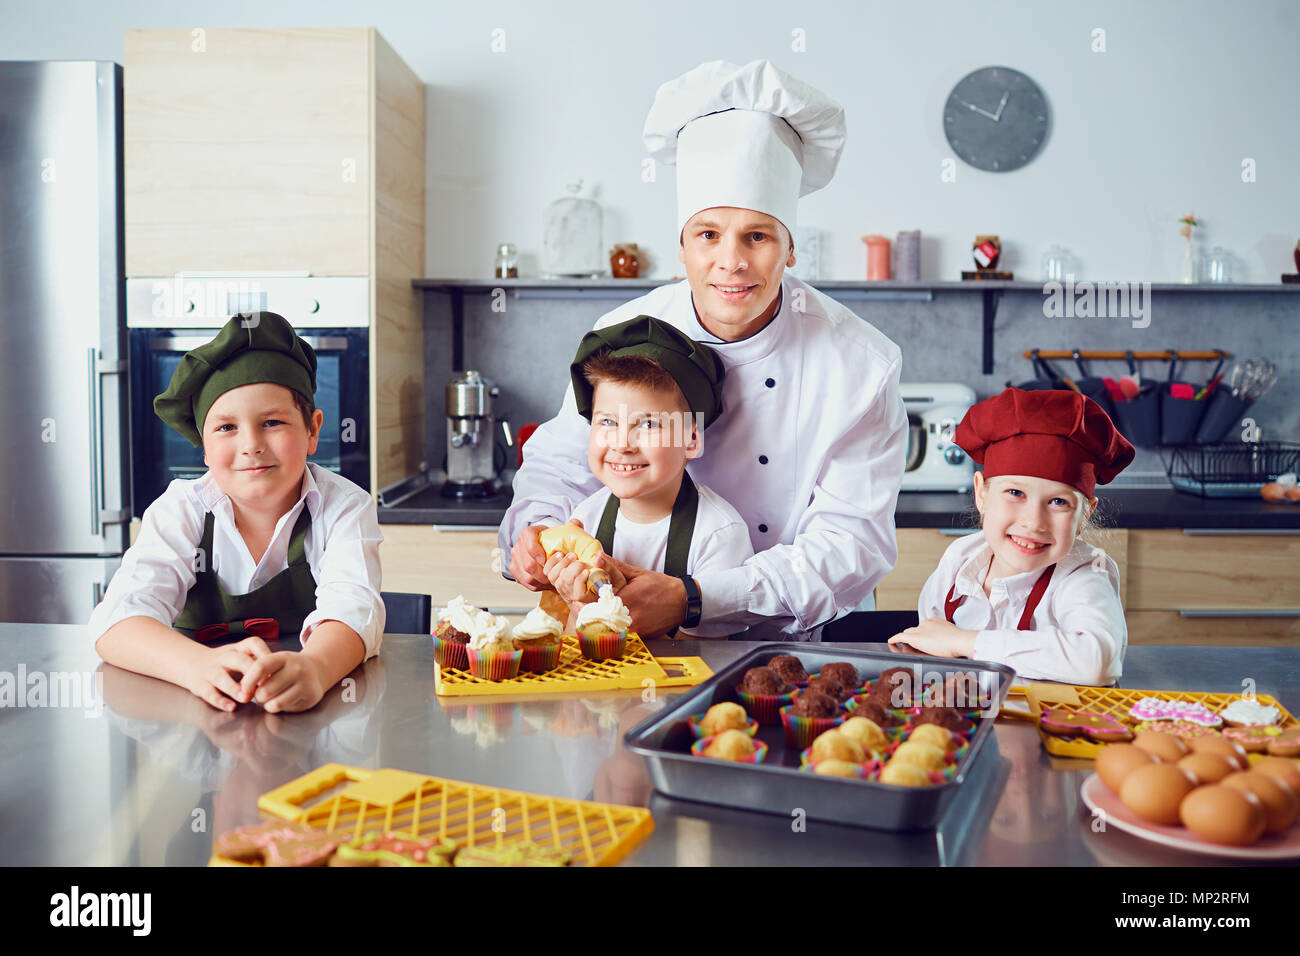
88, 462, 385, 658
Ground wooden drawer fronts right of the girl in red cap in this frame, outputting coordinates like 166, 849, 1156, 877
1127, 529, 1300, 644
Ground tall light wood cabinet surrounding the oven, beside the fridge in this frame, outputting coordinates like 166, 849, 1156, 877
124, 27, 425, 492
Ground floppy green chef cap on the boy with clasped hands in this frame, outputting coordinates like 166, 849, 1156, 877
153, 312, 316, 447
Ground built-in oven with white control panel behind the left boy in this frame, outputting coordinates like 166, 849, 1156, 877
127, 277, 371, 518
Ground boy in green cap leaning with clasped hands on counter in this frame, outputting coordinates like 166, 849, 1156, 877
90, 312, 385, 713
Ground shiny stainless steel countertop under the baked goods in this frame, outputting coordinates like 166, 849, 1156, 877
0, 624, 1300, 866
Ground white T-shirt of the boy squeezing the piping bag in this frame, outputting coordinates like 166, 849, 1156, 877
571, 485, 754, 637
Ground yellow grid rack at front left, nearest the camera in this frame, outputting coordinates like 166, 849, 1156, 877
208, 763, 654, 866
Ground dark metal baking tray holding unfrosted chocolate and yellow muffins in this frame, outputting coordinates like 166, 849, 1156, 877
624, 644, 1015, 830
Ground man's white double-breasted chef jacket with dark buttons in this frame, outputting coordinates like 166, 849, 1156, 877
499, 273, 907, 640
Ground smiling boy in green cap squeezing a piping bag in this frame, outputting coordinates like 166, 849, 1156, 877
538, 316, 754, 637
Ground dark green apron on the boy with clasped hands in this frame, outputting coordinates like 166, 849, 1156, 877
172, 503, 316, 644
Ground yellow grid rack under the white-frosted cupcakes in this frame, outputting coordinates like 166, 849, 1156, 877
433, 633, 714, 697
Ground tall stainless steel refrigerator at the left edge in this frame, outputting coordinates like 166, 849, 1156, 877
0, 61, 131, 624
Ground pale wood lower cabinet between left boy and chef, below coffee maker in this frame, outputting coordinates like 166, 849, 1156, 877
380, 524, 538, 611
